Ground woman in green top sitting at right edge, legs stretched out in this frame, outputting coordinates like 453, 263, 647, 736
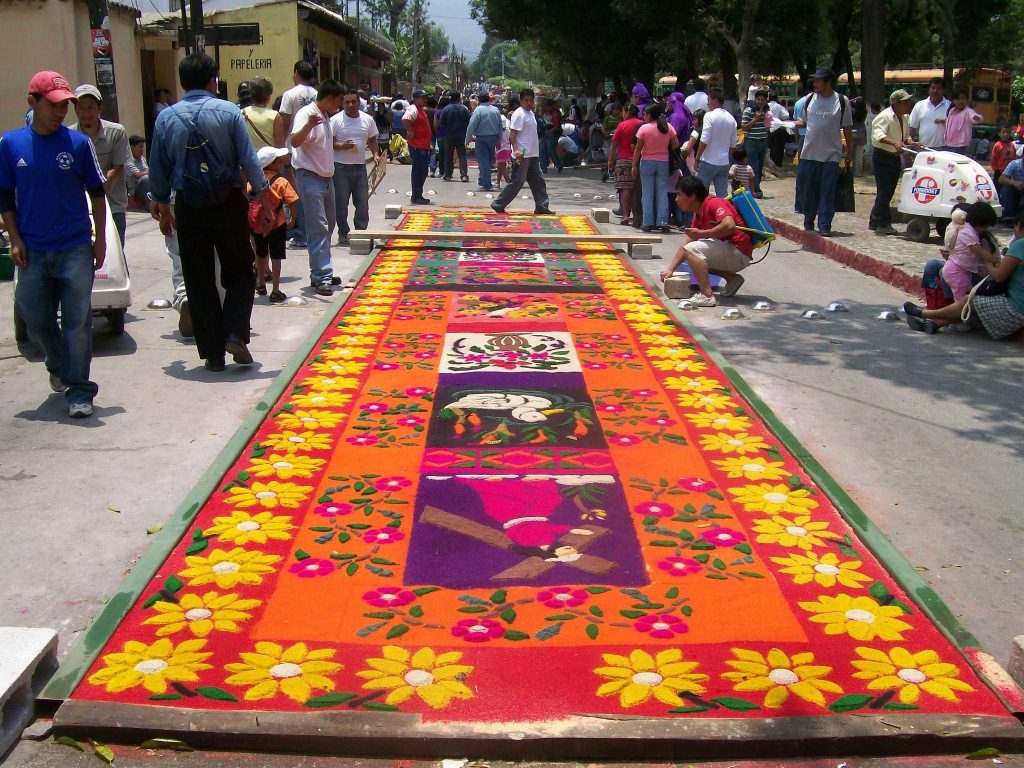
903, 213, 1024, 339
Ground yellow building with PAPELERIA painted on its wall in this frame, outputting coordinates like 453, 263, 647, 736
143, 0, 394, 118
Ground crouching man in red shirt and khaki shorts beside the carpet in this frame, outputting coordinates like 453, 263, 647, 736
662, 176, 754, 306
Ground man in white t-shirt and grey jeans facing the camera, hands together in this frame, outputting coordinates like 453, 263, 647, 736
331, 88, 380, 246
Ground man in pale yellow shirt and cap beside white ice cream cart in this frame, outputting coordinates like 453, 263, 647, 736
867, 88, 921, 234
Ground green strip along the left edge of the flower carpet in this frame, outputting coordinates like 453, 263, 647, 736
38, 250, 386, 701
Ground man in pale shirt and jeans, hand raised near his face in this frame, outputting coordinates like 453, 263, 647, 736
290, 80, 344, 296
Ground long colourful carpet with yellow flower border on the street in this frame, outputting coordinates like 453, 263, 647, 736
74, 212, 1009, 723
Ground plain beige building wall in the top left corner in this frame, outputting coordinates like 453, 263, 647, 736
0, 0, 145, 134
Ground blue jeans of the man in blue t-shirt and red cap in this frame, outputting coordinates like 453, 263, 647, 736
14, 245, 99, 406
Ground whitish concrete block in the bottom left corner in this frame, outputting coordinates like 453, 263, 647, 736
0, 627, 57, 755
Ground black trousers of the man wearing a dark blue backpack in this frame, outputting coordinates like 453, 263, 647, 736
174, 189, 256, 359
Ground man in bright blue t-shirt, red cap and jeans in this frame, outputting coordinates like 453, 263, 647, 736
0, 72, 106, 419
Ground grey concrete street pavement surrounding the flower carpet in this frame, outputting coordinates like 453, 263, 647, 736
0, 165, 1024, 766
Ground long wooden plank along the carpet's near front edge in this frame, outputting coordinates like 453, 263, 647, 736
53, 704, 1024, 762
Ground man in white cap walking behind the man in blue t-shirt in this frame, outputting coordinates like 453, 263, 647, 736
71, 83, 132, 248
